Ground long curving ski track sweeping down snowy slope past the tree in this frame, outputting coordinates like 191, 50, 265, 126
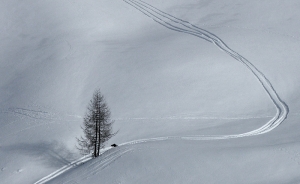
35, 0, 289, 184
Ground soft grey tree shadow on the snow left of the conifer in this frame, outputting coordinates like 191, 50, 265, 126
1, 141, 78, 168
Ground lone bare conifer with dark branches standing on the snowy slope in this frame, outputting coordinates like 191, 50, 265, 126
77, 89, 116, 157
